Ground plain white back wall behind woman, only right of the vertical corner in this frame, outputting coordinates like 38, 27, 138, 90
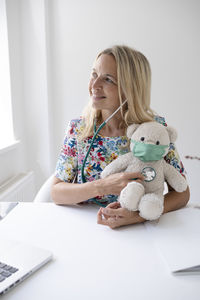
49, 0, 200, 162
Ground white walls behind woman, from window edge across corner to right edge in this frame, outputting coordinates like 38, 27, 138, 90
2, 0, 200, 195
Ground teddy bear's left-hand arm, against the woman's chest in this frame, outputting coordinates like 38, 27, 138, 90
101, 152, 133, 178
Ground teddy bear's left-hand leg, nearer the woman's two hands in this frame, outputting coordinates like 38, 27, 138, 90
118, 181, 144, 211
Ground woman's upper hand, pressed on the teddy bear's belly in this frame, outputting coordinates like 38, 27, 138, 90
94, 172, 144, 196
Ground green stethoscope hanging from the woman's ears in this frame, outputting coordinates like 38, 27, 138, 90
81, 100, 127, 206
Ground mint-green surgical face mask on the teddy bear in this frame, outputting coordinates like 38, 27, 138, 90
131, 139, 169, 162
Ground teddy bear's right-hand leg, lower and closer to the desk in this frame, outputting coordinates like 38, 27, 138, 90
139, 194, 164, 221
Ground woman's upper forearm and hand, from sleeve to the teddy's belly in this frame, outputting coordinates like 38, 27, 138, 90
51, 172, 144, 205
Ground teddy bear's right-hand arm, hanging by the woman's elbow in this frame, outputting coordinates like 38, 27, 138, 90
163, 160, 187, 193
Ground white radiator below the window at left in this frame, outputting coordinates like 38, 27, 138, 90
0, 172, 36, 202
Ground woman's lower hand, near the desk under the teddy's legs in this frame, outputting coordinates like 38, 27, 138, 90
97, 202, 145, 229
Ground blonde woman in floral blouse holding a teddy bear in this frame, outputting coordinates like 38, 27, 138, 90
52, 46, 189, 228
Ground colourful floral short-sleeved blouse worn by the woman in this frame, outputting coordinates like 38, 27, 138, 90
55, 116, 184, 206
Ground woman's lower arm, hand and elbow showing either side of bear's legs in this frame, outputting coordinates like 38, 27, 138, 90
97, 186, 190, 229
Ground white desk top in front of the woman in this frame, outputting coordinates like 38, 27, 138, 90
0, 203, 200, 300
